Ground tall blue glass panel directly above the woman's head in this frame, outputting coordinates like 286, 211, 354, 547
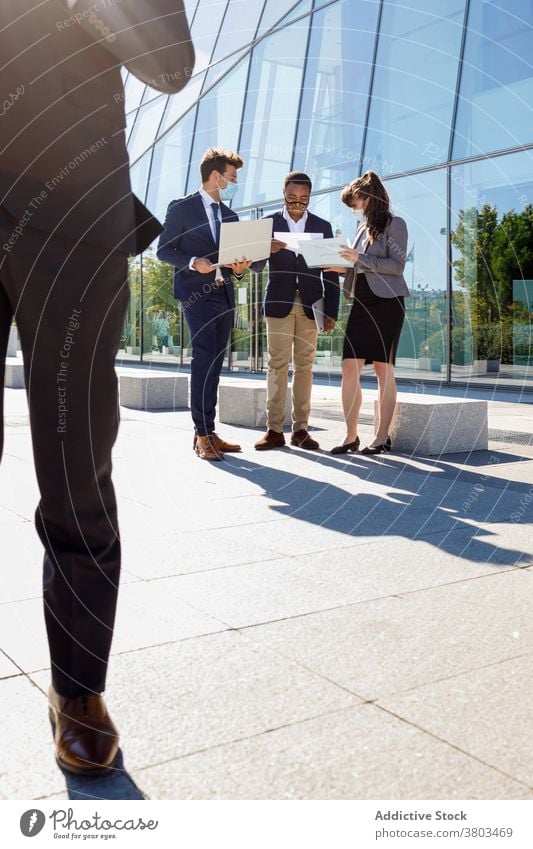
363, 0, 464, 175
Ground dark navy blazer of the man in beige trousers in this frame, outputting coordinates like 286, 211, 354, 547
254, 212, 340, 319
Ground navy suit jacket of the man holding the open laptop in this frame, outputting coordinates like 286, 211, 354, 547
157, 192, 239, 306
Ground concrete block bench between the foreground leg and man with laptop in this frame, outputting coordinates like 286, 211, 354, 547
119, 373, 189, 410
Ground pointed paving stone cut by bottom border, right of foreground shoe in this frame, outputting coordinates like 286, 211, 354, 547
134, 705, 533, 799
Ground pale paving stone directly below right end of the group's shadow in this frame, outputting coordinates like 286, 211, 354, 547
154, 526, 524, 628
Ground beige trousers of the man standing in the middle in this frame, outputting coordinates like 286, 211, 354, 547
266, 293, 318, 433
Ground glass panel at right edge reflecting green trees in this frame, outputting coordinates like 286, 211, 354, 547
451, 151, 533, 384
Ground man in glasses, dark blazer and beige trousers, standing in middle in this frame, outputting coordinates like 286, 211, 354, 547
254, 171, 339, 451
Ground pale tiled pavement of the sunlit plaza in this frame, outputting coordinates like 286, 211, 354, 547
0, 386, 533, 799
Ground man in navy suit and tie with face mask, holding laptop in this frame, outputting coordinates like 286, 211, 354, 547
157, 148, 251, 460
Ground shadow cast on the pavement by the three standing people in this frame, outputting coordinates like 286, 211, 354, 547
213, 450, 532, 566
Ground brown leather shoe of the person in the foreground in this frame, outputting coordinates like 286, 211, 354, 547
48, 687, 118, 775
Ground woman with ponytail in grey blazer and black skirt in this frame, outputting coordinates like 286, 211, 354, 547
324, 171, 409, 454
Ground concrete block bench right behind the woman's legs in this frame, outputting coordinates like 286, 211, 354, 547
380, 395, 488, 455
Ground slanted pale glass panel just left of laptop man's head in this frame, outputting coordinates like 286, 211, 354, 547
147, 109, 196, 220
